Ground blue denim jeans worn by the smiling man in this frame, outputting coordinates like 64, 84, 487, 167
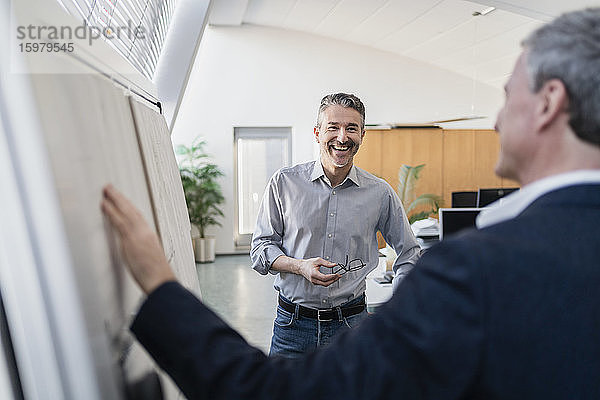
269, 296, 368, 358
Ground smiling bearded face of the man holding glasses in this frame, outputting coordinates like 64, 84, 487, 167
315, 104, 365, 174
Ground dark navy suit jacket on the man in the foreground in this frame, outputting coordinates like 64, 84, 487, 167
132, 185, 600, 400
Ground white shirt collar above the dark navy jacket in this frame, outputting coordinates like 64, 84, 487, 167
476, 169, 600, 229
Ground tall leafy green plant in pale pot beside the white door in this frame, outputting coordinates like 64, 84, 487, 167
176, 138, 225, 262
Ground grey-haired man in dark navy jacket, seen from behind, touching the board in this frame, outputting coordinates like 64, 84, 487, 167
102, 8, 600, 400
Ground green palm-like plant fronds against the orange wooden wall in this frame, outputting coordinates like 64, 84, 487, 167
398, 164, 443, 224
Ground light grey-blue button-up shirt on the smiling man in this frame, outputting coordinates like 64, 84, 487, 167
250, 160, 421, 309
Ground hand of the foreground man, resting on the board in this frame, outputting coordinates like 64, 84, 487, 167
101, 185, 176, 294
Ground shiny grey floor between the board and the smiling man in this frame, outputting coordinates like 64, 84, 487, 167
196, 255, 277, 354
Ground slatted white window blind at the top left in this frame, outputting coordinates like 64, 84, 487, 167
58, 0, 176, 80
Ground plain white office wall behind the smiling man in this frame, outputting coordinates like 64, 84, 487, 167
173, 25, 503, 253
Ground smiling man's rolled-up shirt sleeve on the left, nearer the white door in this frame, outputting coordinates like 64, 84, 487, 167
250, 173, 285, 275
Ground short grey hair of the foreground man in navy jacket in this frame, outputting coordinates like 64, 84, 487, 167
522, 8, 600, 146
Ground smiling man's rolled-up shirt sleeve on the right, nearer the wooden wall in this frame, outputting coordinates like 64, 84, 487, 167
379, 183, 422, 290
